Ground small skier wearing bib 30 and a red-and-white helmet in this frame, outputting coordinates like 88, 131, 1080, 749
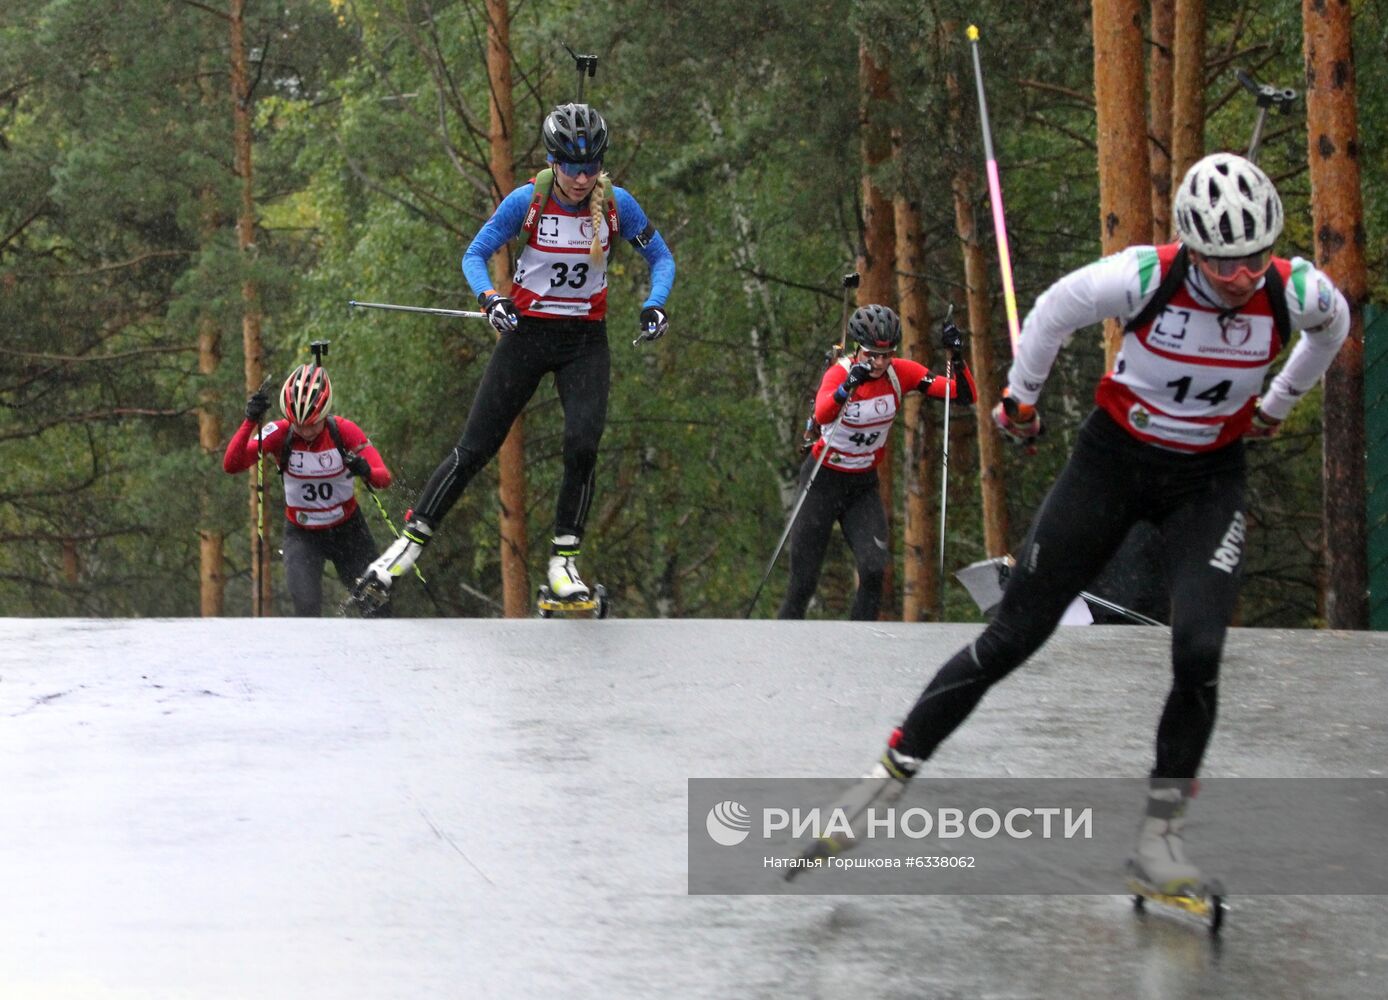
222, 364, 390, 618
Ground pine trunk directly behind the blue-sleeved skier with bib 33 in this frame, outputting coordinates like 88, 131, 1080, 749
487, 0, 530, 618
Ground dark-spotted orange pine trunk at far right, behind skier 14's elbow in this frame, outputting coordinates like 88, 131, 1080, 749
1302, 0, 1369, 629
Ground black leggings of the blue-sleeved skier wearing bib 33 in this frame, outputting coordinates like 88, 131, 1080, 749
415, 317, 612, 536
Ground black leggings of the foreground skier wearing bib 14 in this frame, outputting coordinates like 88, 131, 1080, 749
899, 411, 1245, 779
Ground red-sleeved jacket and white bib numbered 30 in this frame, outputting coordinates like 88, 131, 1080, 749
222, 417, 391, 531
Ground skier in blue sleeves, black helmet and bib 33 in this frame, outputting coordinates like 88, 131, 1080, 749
349, 104, 675, 606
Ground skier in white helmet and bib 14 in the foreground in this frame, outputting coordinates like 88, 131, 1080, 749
808, 153, 1349, 897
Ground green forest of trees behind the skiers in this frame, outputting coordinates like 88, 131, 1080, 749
0, 0, 1388, 626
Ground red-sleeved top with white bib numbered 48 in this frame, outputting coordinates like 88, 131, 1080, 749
813, 357, 979, 472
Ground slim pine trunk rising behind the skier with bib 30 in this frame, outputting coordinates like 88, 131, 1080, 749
230, 0, 273, 617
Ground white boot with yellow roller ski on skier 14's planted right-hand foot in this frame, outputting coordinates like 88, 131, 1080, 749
1127, 782, 1228, 935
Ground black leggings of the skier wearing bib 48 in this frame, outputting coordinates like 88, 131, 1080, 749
776, 456, 888, 621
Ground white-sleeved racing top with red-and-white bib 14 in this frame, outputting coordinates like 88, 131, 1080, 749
1008, 243, 1349, 451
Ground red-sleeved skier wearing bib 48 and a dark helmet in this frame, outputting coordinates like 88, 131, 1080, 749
776, 306, 977, 621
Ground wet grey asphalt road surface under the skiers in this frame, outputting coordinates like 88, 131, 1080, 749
0, 619, 1388, 1000
